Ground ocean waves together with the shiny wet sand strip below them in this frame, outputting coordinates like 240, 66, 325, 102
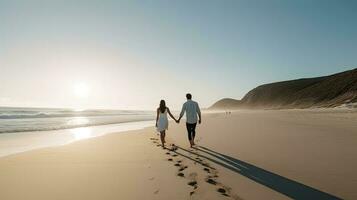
0, 107, 156, 157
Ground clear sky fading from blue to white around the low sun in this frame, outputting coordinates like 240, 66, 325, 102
0, 0, 357, 109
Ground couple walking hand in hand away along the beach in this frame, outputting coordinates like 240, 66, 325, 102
156, 93, 201, 148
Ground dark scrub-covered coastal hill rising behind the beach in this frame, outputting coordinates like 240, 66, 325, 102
211, 68, 357, 109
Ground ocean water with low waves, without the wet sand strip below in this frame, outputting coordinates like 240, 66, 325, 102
0, 107, 156, 134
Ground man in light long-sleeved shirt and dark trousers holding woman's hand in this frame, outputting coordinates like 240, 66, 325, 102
176, 93, 201, 147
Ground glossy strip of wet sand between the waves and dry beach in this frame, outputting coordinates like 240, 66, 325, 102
0, 120, 154, 158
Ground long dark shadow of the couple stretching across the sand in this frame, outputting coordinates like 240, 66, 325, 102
178, 146, 341, 200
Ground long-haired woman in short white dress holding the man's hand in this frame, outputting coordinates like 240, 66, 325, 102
156, 100, 177, 148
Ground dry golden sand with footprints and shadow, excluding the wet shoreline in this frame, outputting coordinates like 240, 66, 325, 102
0, 110, 357, 200
